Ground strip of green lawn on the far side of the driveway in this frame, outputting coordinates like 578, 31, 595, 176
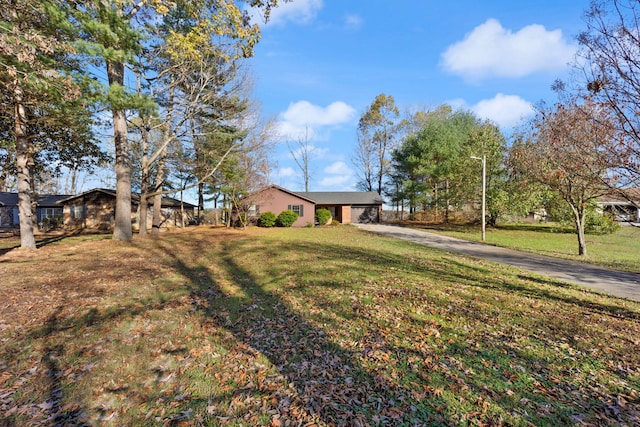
411, 224, 640, 273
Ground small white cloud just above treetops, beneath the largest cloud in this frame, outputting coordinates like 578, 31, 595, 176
470, 93, 533, 128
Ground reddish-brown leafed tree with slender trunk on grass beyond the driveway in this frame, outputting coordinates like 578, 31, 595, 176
509, 98, 617, 255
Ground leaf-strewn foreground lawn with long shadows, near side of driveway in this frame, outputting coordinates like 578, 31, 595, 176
0, 226, 640, 426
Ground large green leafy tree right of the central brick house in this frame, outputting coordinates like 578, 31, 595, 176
393, 105, 505, 221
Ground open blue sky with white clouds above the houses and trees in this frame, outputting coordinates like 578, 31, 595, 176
251, 0, 588, 191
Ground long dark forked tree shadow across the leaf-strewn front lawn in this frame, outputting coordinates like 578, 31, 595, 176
150, 237, 456, 426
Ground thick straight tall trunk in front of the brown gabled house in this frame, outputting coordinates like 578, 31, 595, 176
107, 61, 133, 242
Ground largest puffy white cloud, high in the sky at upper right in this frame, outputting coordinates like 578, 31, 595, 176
442, 19, 577, 79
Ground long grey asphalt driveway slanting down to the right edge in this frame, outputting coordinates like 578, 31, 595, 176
354, 224, 640, 301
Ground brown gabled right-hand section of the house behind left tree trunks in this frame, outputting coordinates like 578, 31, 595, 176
60, 188, 196, 231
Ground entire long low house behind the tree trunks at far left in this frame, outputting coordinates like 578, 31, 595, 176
0, 188, 196, 231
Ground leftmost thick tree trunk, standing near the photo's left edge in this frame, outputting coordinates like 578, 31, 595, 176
14, 87, 36, 249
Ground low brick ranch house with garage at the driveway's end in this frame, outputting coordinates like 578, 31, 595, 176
244, 185, 383, 227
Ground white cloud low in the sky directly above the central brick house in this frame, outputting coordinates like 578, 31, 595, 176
278, 101, 356, 141
